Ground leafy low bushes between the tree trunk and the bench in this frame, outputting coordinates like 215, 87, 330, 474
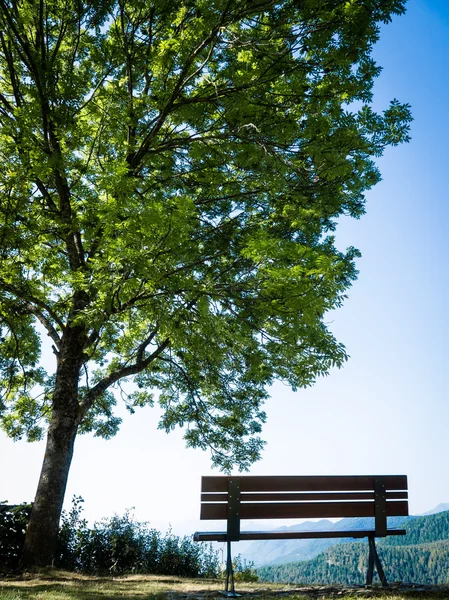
56, 496, 219, 577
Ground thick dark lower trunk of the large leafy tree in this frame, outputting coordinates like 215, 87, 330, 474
20, 328, 82, 569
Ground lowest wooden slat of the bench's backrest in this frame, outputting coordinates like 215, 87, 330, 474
200, 500, 408, 520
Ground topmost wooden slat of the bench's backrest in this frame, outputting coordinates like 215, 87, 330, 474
201, 475, 407, 492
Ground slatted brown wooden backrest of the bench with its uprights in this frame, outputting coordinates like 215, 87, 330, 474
200, 475, 408, 540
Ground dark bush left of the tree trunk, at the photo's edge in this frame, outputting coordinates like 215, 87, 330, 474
0, 502, 31, 571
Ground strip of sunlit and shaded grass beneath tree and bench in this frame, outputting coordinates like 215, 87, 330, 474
0, 571, 449, 600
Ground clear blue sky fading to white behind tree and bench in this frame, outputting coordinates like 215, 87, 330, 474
0, 0, 449, 533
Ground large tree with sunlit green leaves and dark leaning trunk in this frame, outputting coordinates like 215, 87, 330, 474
0, 0, 410, 566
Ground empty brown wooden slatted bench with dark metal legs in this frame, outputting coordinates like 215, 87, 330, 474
194, 475, 408, 596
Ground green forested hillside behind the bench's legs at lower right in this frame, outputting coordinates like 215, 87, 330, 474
257, 511, 449, 584
